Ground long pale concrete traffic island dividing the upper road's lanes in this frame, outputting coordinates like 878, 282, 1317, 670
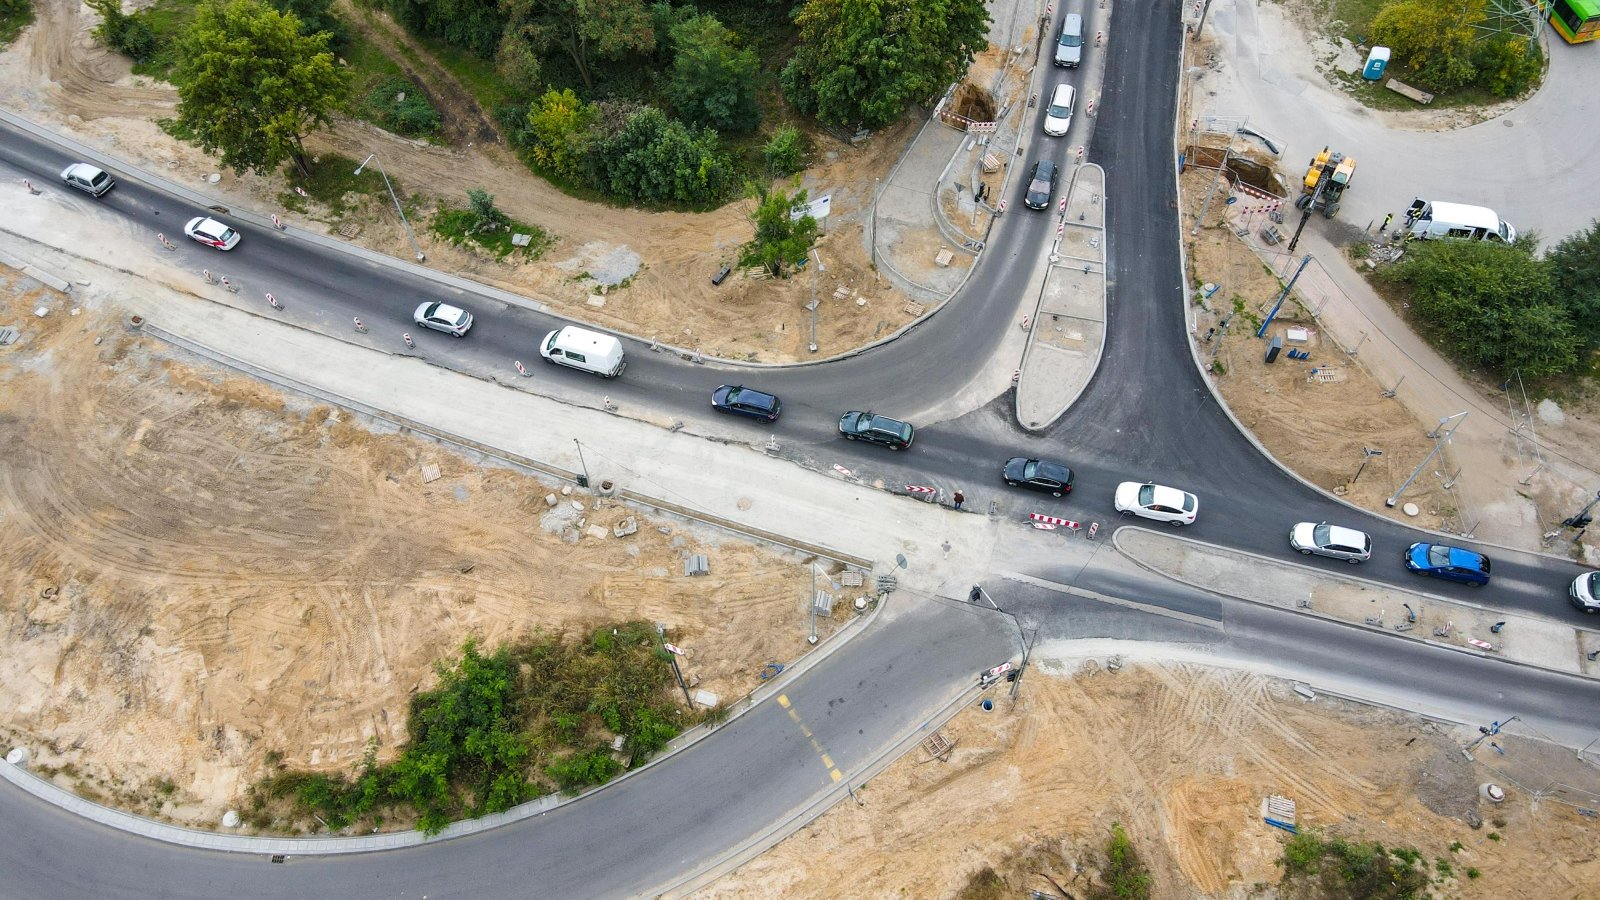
1016, 163, 1106, 431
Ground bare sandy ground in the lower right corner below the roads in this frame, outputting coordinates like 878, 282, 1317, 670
698, 663, 1600, 900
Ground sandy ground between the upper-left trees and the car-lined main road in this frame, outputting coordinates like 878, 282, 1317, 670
0, 0, 918, 362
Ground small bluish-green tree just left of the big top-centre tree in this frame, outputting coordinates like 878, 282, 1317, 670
667, 16, 762, 131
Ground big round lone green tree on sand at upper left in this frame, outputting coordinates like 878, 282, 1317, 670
173, 0, 349, 175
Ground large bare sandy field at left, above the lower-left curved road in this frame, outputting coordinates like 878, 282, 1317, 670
0, 269, 829, 825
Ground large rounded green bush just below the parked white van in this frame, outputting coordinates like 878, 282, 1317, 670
1392, 240, 1584, 378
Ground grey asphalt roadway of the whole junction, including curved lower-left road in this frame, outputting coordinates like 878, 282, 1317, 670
0, 0, 1592, 898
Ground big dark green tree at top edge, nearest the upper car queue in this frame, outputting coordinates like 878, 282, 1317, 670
782, 0, 989, 128
